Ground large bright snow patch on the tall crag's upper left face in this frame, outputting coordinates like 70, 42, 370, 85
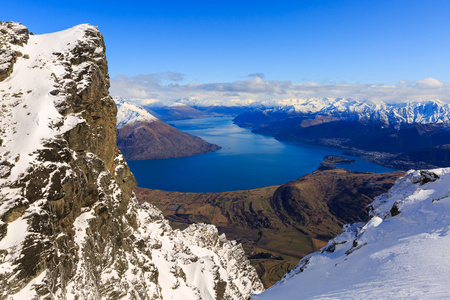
0, 24, 90, 185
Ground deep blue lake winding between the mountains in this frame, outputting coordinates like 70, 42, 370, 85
128, 118, 393, 192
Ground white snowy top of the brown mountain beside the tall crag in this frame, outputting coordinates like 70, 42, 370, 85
114, 97, 158, 128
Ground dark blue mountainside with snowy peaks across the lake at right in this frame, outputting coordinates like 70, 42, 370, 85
230, 99, 450, 170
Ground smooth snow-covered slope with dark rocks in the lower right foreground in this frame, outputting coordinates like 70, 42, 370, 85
252, 168, 450, 300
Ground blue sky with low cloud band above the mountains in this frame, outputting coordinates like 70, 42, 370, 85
0, 0, 450, 102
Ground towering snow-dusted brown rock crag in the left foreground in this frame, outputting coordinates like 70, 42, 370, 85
0, 22, 263, 299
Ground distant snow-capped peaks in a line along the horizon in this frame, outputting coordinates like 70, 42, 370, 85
152, 98, 450, 126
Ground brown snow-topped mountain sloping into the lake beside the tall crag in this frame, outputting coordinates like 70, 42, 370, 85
114, 98, 220, 160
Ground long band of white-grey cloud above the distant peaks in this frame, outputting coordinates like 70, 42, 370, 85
111, 72, 450, 105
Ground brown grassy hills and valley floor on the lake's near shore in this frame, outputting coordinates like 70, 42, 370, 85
135, 164, 404, 287
